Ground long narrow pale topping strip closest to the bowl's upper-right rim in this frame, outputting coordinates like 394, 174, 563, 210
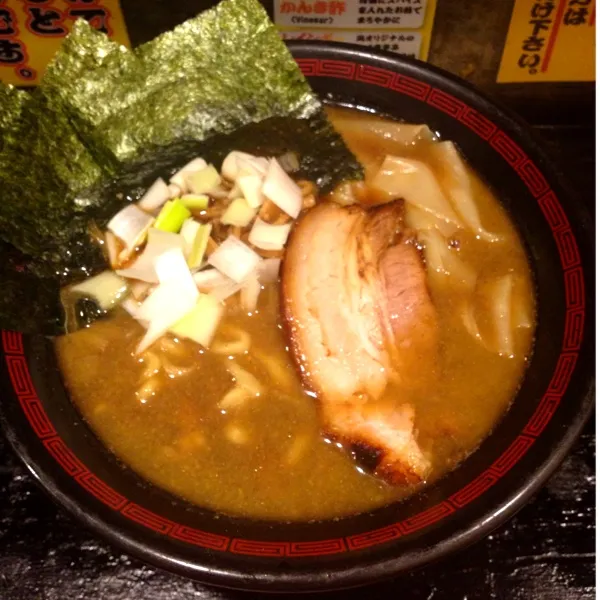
431, 141, 499, 242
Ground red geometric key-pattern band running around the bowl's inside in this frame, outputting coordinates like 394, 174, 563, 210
2, 58, 585, 559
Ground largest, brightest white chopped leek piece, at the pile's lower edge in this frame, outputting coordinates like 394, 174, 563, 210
136, 248, 199, 354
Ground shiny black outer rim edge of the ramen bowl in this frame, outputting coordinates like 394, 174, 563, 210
0, 41, 594, 591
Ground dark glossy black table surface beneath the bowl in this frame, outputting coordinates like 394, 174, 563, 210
0, 119, 596, 600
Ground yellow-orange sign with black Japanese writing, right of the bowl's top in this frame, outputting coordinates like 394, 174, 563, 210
497, 0, 596, 83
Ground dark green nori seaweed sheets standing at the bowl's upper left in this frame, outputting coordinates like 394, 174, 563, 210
0, 0, 363, 333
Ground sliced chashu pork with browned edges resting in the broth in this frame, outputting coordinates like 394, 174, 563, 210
282, 201, 437, 483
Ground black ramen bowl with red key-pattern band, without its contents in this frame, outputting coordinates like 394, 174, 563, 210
0, 43, 594, 591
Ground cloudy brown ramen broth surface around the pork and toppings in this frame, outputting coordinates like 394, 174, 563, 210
56, 109, 534, 520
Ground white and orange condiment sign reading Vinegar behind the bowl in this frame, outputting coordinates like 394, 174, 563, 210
274, 0, 436, 60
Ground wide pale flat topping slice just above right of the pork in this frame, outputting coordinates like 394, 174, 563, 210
371, 155, 463, 227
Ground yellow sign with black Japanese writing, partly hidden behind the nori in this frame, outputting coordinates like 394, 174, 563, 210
0, 0, 129, 86
